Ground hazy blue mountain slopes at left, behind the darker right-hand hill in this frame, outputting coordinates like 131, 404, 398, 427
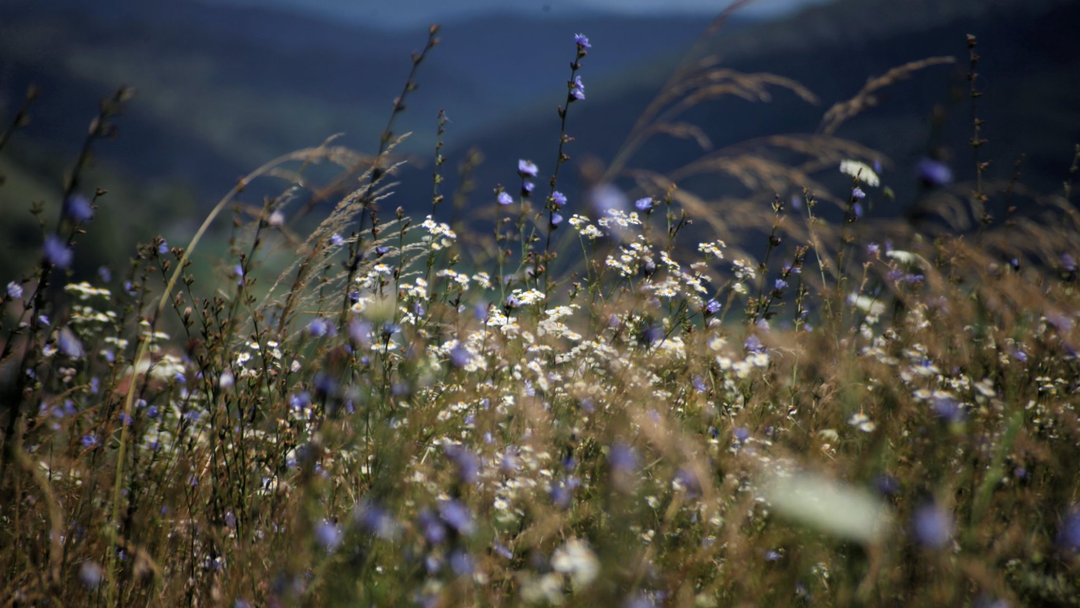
0, 0, 725, 194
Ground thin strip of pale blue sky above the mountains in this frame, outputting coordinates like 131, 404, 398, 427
204, 0, 826, 26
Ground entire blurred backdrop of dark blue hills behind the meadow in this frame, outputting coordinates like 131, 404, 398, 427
0, 0, 1080, 272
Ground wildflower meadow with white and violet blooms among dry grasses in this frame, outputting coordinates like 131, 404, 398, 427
0, 13, 1080, 608
